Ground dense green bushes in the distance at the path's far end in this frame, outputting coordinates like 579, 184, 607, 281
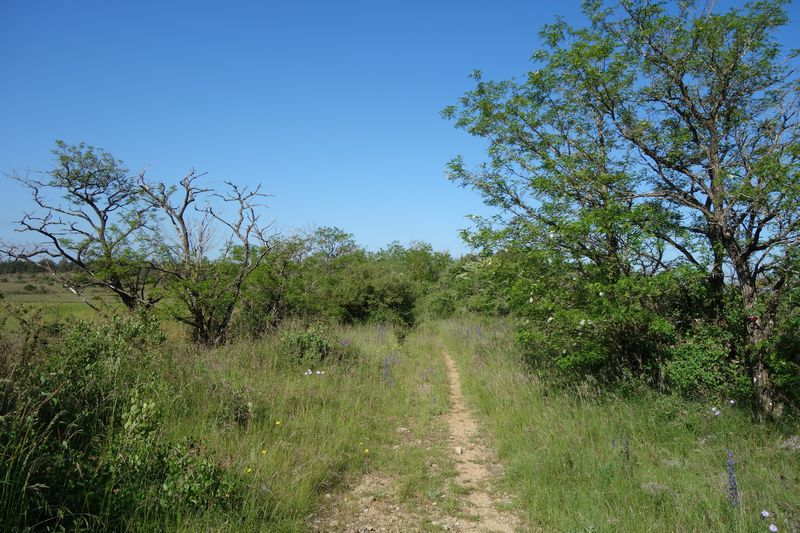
234, 235, 452, 338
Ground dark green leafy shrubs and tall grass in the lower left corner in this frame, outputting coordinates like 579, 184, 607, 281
0, 318, 234, 531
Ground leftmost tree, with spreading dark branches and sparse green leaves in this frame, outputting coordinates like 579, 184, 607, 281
2, 141, 158, 310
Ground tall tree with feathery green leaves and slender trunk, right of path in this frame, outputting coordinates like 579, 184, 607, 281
445, 0, 800, 414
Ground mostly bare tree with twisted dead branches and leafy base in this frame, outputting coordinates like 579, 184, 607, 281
138, 171, 270, 345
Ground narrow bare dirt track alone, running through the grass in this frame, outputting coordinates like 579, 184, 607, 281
444, 352, 519, 533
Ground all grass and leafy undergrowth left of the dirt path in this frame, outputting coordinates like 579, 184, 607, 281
0, 314, 460, 532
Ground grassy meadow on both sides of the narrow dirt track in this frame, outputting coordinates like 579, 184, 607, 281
0, 276, 800, 533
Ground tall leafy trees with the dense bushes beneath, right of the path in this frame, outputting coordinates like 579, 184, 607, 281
443, 0, 800, 415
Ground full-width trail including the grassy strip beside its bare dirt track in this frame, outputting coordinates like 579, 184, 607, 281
310, 328, 520, 533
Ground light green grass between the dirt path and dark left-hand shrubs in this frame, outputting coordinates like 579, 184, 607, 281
137, 326, 460, 532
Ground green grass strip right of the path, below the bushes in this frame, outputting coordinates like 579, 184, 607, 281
437, 320, 800, 533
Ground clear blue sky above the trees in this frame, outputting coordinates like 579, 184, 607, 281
0, 0, 800, 254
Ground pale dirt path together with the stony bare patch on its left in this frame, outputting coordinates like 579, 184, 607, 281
310, 352, 524, 533
